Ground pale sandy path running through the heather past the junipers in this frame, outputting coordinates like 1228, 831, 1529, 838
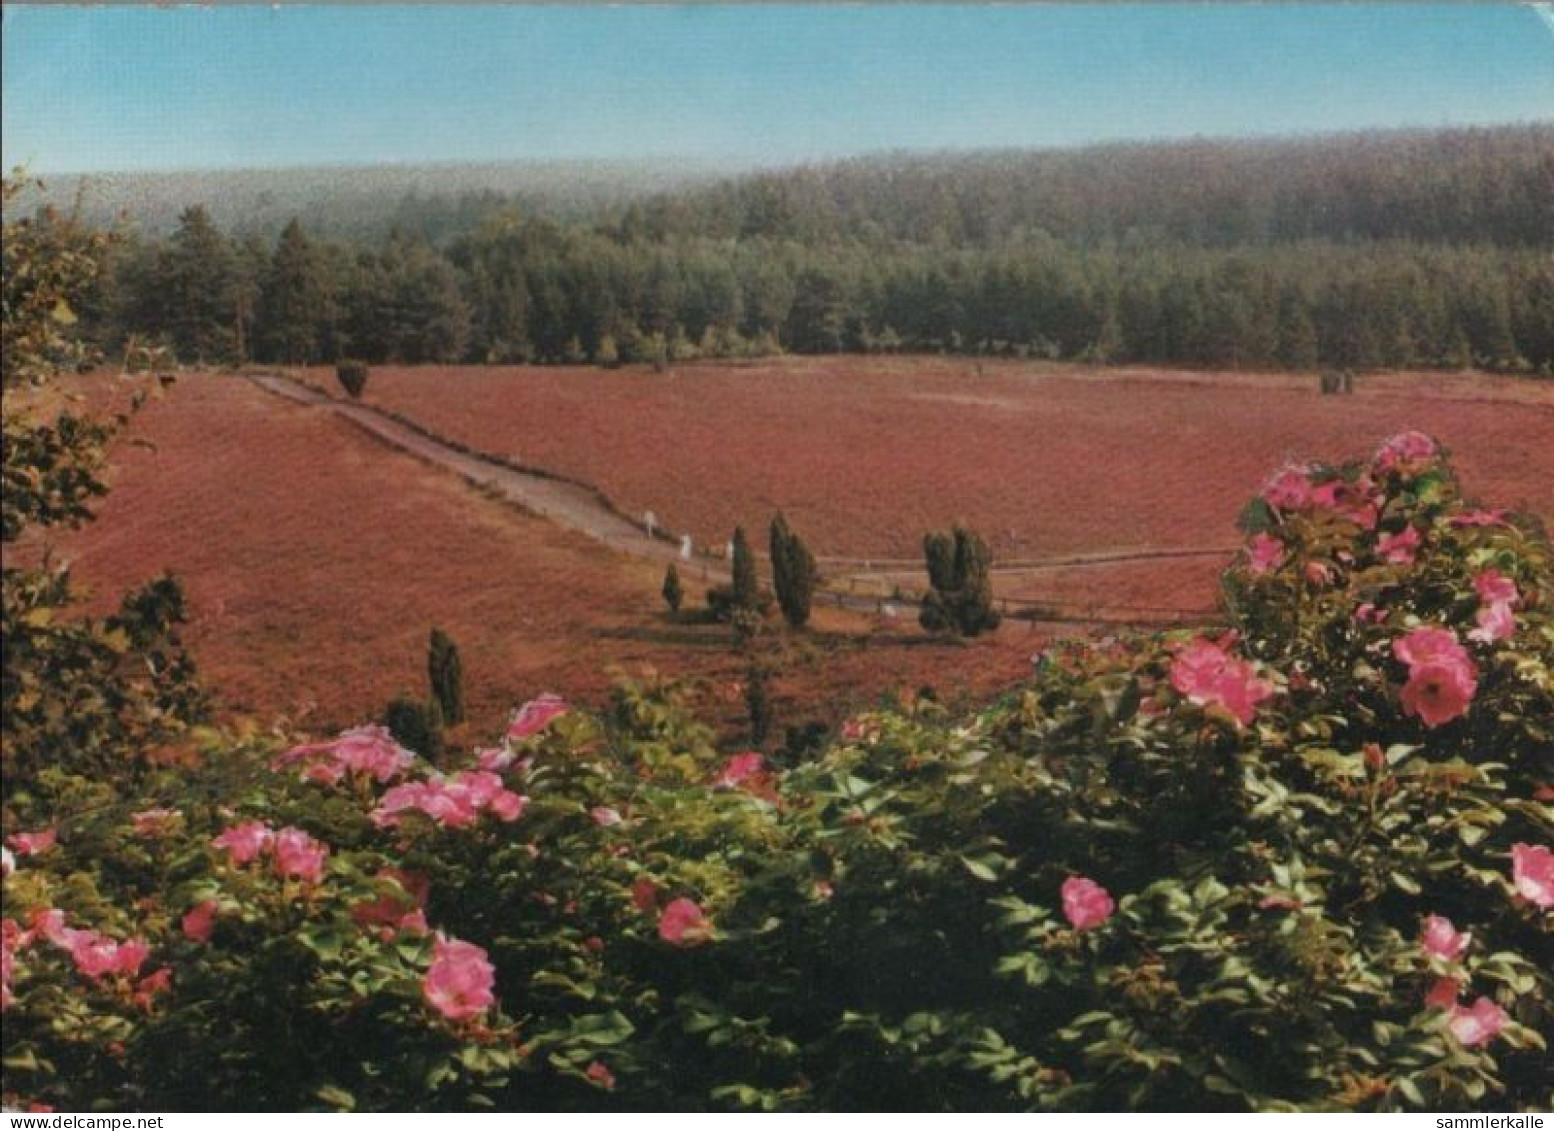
242, 371, 1231, 626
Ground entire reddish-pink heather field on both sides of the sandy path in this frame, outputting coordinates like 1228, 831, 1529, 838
33, 359, 1554, 733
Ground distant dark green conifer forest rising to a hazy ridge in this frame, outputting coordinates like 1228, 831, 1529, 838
45, 126, 1554, 376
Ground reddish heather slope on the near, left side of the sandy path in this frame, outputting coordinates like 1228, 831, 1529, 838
33, 374, 1044, 738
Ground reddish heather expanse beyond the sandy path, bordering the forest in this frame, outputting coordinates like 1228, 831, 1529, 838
299, 357, 1554, 565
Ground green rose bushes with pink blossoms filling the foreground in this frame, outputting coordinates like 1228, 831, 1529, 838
5, 435, 1554, 1109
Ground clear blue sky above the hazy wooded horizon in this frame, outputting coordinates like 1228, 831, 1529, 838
3, 3, 1554, 172
